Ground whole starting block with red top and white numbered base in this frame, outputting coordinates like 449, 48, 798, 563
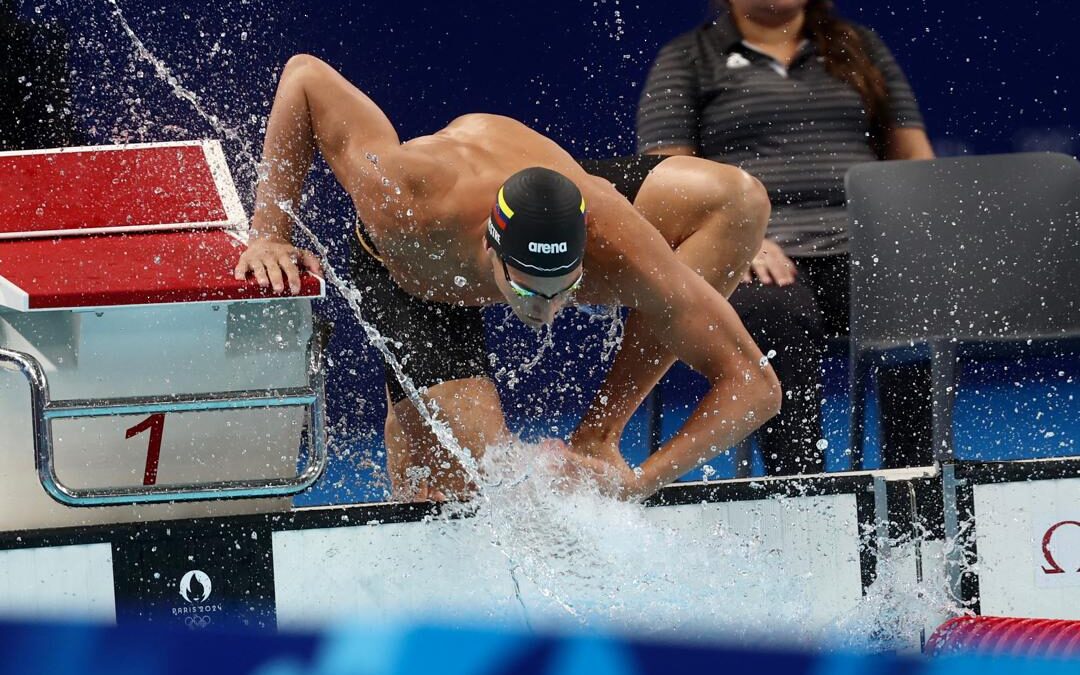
0, 141, 326, 530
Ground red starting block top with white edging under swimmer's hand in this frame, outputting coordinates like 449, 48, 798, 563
0, 141, 323, 311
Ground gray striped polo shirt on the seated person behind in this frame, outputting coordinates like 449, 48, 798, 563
637, 14, 922, 256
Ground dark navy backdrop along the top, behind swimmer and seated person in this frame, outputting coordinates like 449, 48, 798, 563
38, 0, 1080, 157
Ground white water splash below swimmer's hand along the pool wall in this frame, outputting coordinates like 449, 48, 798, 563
447, 443, 958, 650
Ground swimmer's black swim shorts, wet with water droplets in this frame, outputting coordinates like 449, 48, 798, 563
350, 154, 666, 404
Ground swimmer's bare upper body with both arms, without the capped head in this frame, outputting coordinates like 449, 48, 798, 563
237, 56, 781, 495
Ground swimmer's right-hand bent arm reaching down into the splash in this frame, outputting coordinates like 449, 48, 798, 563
586, 192, 780, 497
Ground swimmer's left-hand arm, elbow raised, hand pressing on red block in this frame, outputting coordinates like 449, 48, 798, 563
235, 55, 400, 293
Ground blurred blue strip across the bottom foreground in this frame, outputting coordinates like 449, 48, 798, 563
0, 623, 1080, 675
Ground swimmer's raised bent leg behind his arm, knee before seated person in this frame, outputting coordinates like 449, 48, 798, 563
571, 157, 770, 455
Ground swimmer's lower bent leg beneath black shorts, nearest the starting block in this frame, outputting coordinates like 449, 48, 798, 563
387, 377, 510, 499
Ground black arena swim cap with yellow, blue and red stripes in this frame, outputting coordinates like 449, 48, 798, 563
487, 166, 585, 276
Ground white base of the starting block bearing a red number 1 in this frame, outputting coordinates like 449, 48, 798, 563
0, 299, 312, 530
